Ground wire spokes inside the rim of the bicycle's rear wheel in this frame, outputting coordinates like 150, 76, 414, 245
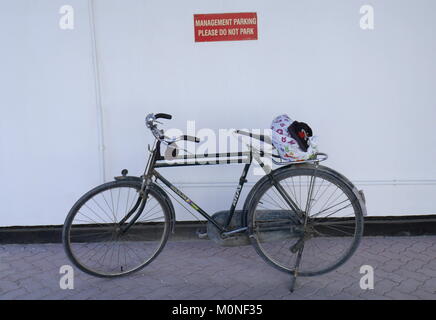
253, 174, 357, 274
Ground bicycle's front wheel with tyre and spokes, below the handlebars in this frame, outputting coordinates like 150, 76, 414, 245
63, 181, 170, 277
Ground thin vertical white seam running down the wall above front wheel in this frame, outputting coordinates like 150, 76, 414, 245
88, 0, 106, 183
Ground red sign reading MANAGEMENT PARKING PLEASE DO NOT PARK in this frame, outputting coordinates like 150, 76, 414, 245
194, 12, 257, 42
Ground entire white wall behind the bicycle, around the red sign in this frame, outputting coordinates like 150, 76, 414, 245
0, 0, 436, 226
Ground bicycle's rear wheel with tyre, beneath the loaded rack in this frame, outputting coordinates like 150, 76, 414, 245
247, 165, 363, 276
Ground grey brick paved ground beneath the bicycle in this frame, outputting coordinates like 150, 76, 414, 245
0, 236, 436, 299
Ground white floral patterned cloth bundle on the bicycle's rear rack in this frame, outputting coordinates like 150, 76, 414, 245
271, 114, 318, 161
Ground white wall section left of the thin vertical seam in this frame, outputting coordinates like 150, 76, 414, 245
0, 0, 99, 226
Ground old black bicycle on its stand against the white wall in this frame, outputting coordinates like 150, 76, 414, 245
62, 113, 366, 291
